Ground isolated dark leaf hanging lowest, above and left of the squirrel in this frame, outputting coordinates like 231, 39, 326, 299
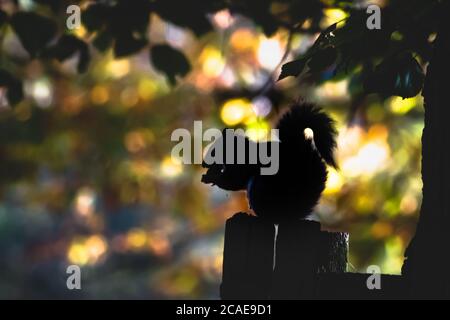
151, 45, 191, 85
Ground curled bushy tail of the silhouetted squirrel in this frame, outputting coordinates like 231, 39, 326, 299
277, 103, 337, 168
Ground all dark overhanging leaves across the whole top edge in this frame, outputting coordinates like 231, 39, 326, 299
0, 0, 439, 104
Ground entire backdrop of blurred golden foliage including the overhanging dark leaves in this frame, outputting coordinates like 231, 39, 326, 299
0, 0, 440, 298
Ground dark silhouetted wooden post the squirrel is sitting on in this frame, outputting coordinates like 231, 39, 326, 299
221, 213, 348, 299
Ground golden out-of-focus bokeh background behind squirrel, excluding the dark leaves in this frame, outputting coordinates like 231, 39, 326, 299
0, 1, 423, 299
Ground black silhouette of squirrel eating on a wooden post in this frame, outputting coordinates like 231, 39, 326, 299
202, 103, 337, 223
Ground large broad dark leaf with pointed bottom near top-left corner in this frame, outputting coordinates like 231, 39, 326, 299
11, 12, 56, 58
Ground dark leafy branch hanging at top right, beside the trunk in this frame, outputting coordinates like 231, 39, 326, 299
279, 1, 436, 98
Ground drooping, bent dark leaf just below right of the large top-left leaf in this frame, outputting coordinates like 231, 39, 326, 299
42, 35, 90, 73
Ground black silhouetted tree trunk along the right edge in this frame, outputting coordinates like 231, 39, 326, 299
403, 2, 450, 298
